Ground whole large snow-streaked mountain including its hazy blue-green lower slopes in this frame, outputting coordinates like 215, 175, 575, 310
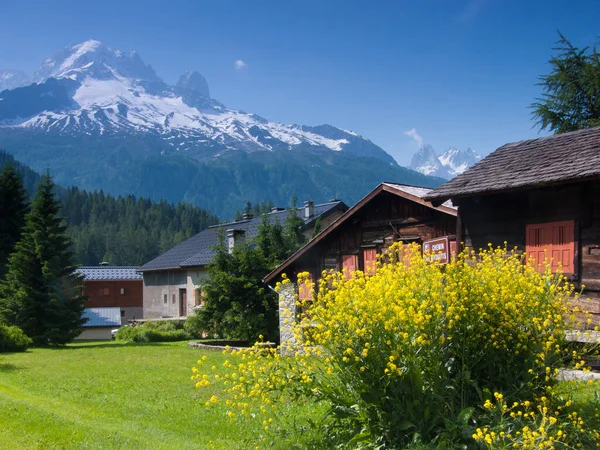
0, 40, 443, 218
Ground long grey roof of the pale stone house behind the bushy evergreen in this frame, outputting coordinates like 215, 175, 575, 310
138, 201, 348, 272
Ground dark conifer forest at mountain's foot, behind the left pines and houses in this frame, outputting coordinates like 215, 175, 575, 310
0, 151, 218, 265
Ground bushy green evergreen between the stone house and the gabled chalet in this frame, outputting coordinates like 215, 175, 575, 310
195, 202, 306, 342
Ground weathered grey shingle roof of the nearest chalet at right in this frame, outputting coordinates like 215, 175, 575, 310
425, 127, 600, 201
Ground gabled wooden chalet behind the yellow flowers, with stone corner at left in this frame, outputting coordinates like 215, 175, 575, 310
263, 183, 456, 342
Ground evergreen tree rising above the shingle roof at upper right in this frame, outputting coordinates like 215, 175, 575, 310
531, 32, 600, 133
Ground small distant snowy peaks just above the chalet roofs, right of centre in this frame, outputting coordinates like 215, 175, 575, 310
409, 145, 481, 179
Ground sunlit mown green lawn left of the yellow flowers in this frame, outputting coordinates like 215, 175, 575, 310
0, 342, 318, 449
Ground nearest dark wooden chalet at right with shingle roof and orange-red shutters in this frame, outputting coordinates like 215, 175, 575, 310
425, 127, 600, 313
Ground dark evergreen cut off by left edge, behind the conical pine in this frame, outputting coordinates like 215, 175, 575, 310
0, 163, 27, 280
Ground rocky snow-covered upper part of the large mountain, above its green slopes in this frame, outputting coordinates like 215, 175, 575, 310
0, 40, 395, 164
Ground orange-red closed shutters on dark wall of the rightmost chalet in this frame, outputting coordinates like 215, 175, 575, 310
525, 220, 575, 275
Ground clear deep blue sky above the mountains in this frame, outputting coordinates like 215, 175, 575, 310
0, 0, 600, 164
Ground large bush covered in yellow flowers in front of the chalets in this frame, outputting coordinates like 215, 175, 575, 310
192, 245, 596, 448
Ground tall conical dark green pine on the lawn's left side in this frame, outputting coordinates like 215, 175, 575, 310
0, 174, 85, 345
